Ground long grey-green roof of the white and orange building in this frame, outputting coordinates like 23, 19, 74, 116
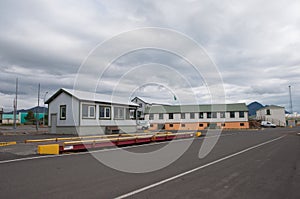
145, 103, 248, 113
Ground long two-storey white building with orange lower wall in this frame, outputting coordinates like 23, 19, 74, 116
145, 103, 249, 131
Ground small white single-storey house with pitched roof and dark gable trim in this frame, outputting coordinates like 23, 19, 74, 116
46, 88, 138, 135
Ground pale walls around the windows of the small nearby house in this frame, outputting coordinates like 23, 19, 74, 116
48, 93, 136, 135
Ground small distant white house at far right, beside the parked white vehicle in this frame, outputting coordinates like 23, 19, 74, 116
256, 105, 286, 126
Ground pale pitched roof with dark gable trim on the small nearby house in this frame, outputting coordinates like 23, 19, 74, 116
45, 88, 138, 106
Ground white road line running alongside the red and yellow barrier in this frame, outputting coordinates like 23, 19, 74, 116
0, 132, 255, 164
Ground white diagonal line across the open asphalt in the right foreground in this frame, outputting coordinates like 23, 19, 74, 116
115, 135, 286, 199
